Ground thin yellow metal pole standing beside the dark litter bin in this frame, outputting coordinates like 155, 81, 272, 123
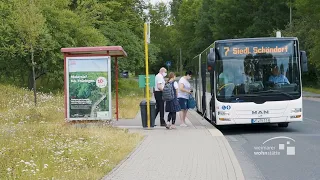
144, 23, 150, 128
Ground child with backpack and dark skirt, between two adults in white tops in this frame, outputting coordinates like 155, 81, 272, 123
166, 72, 181, 129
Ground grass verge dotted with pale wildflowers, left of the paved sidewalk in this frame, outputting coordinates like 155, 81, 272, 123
0, 85, 142, 179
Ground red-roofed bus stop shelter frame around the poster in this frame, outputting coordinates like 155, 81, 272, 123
61, 46, 127, 120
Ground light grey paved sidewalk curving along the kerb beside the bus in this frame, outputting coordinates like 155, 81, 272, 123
103, 111, 244, 180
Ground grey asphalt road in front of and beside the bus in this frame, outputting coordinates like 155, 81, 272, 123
219, 98, 320, 180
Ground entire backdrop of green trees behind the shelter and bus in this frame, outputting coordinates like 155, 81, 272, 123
0, 0, 320, 91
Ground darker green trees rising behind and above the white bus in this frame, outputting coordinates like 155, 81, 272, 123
162, 0, 320, 85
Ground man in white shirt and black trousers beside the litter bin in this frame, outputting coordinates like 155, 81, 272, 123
154, 67, 167, 126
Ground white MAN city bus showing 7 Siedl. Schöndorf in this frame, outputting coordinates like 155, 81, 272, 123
187, 37, 308, 127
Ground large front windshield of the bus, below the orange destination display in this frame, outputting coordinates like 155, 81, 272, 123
215, 53, 301, 102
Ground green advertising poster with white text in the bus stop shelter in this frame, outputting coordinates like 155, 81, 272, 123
66, 56, 112, 120
